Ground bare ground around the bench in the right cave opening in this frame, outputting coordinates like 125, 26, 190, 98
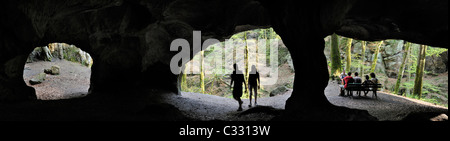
325, 82, 448, 121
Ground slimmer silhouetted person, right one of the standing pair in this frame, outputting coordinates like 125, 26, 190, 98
248, 65, 261, 107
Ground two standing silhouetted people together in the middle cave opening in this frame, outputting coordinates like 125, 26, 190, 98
230, 64, 259, 111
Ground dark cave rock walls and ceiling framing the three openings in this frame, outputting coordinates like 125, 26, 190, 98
0, 0, 448, 120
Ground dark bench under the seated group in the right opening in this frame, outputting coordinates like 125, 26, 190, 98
341, 83, 381, 98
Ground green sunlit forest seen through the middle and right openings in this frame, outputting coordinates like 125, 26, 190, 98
180, 28, 448, 107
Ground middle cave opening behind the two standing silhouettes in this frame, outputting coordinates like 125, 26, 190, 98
178, 28, 295, 113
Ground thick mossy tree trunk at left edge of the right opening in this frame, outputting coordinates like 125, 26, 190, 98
331, 34, 342, 78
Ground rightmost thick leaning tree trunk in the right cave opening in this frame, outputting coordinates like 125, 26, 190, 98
413, 45, 427, 99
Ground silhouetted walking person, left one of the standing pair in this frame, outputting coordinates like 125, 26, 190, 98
230, 64, 247, 111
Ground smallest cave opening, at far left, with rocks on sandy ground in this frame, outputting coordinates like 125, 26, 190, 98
23, 43, 93, 100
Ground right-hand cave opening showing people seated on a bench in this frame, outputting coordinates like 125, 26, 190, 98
324, 34, 448, 120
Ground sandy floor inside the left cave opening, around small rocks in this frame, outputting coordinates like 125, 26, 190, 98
23, 60, 91, 100
